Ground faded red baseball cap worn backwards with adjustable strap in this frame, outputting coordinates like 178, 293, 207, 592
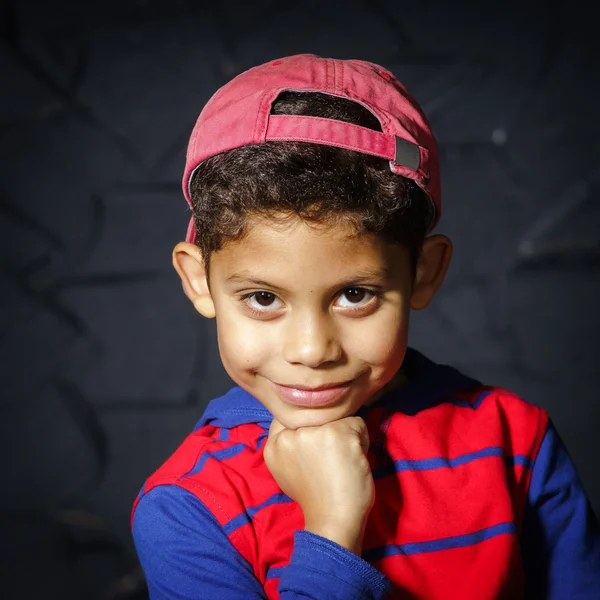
183, 54, 441, 243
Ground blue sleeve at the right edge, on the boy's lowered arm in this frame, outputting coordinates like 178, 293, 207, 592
521, 424, 600, 600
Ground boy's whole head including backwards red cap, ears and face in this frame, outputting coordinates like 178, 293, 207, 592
173, 55, 451, 428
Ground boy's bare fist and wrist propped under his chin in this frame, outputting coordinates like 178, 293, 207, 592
264, 417, 375, 556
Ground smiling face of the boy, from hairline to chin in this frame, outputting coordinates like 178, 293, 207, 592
173, 217, 445, 429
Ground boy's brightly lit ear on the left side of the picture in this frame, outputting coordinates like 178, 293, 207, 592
173, 242, 215, 319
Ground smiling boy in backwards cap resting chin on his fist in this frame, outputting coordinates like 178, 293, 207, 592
132, 55, 600, 600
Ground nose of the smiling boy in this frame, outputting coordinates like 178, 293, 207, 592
284, 314, 342, 368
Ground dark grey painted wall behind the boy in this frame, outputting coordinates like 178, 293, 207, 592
0, 0, 600, 600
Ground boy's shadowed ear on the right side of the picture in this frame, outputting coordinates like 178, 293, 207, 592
410, 235, 452, 310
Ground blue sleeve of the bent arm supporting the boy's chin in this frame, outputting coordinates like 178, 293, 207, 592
132, 485, 389, 600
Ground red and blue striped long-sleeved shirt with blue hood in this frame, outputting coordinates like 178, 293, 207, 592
132, 350, 600, 600
